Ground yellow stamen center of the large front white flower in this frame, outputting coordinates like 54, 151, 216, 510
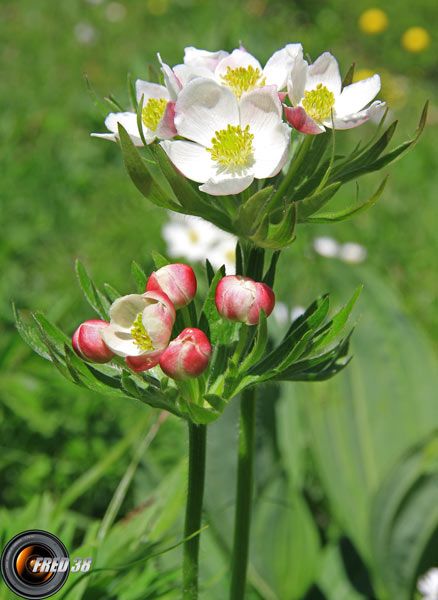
207, 125, 254, 166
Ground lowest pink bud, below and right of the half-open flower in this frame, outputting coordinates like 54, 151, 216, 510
160, 327, 211, 381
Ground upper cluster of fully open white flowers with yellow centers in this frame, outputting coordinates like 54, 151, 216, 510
92, 44, 385, 196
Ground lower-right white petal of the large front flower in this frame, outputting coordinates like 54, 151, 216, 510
253, 122, 291, 179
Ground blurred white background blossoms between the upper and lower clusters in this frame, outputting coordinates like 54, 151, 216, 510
161, 213, 237, 275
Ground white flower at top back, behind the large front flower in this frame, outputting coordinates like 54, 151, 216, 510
173, 44, 302, 98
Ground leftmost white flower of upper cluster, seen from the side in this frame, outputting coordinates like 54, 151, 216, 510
91, 79, 176, 146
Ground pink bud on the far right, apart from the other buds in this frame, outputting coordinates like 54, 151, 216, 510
214, 275, 275, 325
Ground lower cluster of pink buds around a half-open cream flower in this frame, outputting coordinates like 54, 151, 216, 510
72, 263, 275, 381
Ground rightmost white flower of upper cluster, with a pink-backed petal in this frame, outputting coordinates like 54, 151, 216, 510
285, 52, 386, 134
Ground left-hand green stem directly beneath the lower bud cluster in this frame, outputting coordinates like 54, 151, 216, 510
183, 423, 207, 600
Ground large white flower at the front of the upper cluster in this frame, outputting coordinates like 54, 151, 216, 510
161, 77, 290, 195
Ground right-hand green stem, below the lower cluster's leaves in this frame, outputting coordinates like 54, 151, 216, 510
230, 388, 256, 600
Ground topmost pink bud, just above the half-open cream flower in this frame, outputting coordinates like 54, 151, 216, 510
146, 263, 197, 308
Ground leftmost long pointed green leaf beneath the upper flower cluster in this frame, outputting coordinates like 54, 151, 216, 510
118, 123, 181, 212
